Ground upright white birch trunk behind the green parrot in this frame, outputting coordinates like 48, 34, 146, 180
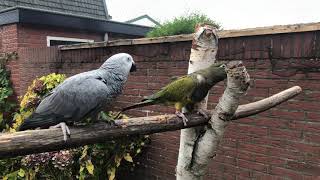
177, 25, 218, 180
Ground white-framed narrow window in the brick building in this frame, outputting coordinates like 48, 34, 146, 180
47, 36, 94, 47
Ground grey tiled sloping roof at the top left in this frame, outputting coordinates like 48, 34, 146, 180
0, 0, 111, 20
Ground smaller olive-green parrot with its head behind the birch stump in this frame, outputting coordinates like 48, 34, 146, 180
119, 63, 227, 125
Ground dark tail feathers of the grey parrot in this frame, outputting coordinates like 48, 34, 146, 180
19, 113, 59, 131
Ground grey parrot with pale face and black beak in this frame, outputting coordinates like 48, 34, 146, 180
19, 53, 136, 141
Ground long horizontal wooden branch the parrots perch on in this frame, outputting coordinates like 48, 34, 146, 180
0, 86, 301, 158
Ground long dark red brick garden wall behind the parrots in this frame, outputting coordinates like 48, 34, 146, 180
11, 31, 320, 179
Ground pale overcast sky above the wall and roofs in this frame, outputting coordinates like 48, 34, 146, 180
106, 0, 320, 29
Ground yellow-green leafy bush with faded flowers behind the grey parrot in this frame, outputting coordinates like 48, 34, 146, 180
0, 74, 149, 180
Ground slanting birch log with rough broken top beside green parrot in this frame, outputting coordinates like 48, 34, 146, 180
180, 61, 250, 179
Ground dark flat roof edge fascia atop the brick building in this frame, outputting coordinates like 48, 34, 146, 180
0, 7, 151, 36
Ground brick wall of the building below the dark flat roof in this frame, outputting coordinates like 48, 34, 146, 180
0, 24, 103, 96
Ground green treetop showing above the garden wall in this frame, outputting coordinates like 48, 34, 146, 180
147, 13, 221, 37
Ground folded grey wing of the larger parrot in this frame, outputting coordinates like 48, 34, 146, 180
35, 78, 111, 121
